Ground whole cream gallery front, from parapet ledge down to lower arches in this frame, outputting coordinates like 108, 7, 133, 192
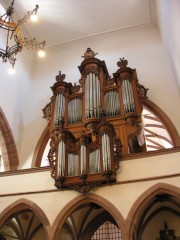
0, 153, 180, 224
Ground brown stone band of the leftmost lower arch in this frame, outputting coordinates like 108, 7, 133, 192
0, 198, 51, 239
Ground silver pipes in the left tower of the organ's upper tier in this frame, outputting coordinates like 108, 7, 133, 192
54, 93, 65, 126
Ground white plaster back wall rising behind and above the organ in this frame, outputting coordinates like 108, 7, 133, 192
20, 27, 180, 168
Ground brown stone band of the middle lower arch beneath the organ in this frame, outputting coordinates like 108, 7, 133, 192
51, 193, 127, 240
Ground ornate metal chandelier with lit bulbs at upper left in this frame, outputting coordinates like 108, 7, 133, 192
0, 0, 46, 68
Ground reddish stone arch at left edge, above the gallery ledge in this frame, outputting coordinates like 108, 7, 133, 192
0, 107, 19, 171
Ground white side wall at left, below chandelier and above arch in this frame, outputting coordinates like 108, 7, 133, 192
0, 50, 33, 158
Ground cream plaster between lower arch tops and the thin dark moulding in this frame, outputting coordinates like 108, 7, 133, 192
0, 177, 180, 225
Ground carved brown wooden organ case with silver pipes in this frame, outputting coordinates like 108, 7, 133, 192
43, 48, 147, 192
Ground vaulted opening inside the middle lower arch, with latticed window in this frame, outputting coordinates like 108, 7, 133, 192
56, 202, 124, 240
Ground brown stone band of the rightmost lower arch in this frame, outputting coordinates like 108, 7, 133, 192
126, 183, 180, 240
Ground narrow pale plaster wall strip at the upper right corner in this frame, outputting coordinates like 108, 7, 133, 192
155, 0, 180, 93
